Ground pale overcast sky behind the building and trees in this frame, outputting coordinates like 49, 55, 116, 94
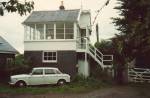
0, 0, 117, 53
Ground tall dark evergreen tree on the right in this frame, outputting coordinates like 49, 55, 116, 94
113, 0, 150, 66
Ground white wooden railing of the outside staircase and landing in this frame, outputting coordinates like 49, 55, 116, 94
77, 37, 113, 68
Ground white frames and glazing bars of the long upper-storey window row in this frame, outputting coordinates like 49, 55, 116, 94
24, 22, 75, 41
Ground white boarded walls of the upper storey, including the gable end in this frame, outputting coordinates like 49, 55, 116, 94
24, 10, 91, 51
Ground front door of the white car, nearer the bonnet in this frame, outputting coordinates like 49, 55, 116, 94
29, 69, 44, 85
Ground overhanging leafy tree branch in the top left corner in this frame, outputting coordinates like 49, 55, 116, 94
0, 0, 34, 16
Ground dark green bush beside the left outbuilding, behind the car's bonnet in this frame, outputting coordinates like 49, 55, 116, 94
0, 55, 31, 82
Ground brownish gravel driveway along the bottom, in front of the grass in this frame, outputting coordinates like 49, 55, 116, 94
0, 86, 150, 98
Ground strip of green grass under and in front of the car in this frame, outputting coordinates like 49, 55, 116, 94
0, 79, 107, 94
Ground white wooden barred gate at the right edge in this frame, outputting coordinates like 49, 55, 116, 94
128, 68, 150, 83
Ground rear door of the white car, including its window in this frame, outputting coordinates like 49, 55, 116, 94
44, 69, 58, 84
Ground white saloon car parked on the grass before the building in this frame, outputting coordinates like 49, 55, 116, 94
9, 67, 70, 87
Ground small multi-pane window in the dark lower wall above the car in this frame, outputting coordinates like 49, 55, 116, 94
43, 51, 57, 62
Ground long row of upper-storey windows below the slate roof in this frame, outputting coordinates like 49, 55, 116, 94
25, 22, 74, 40
